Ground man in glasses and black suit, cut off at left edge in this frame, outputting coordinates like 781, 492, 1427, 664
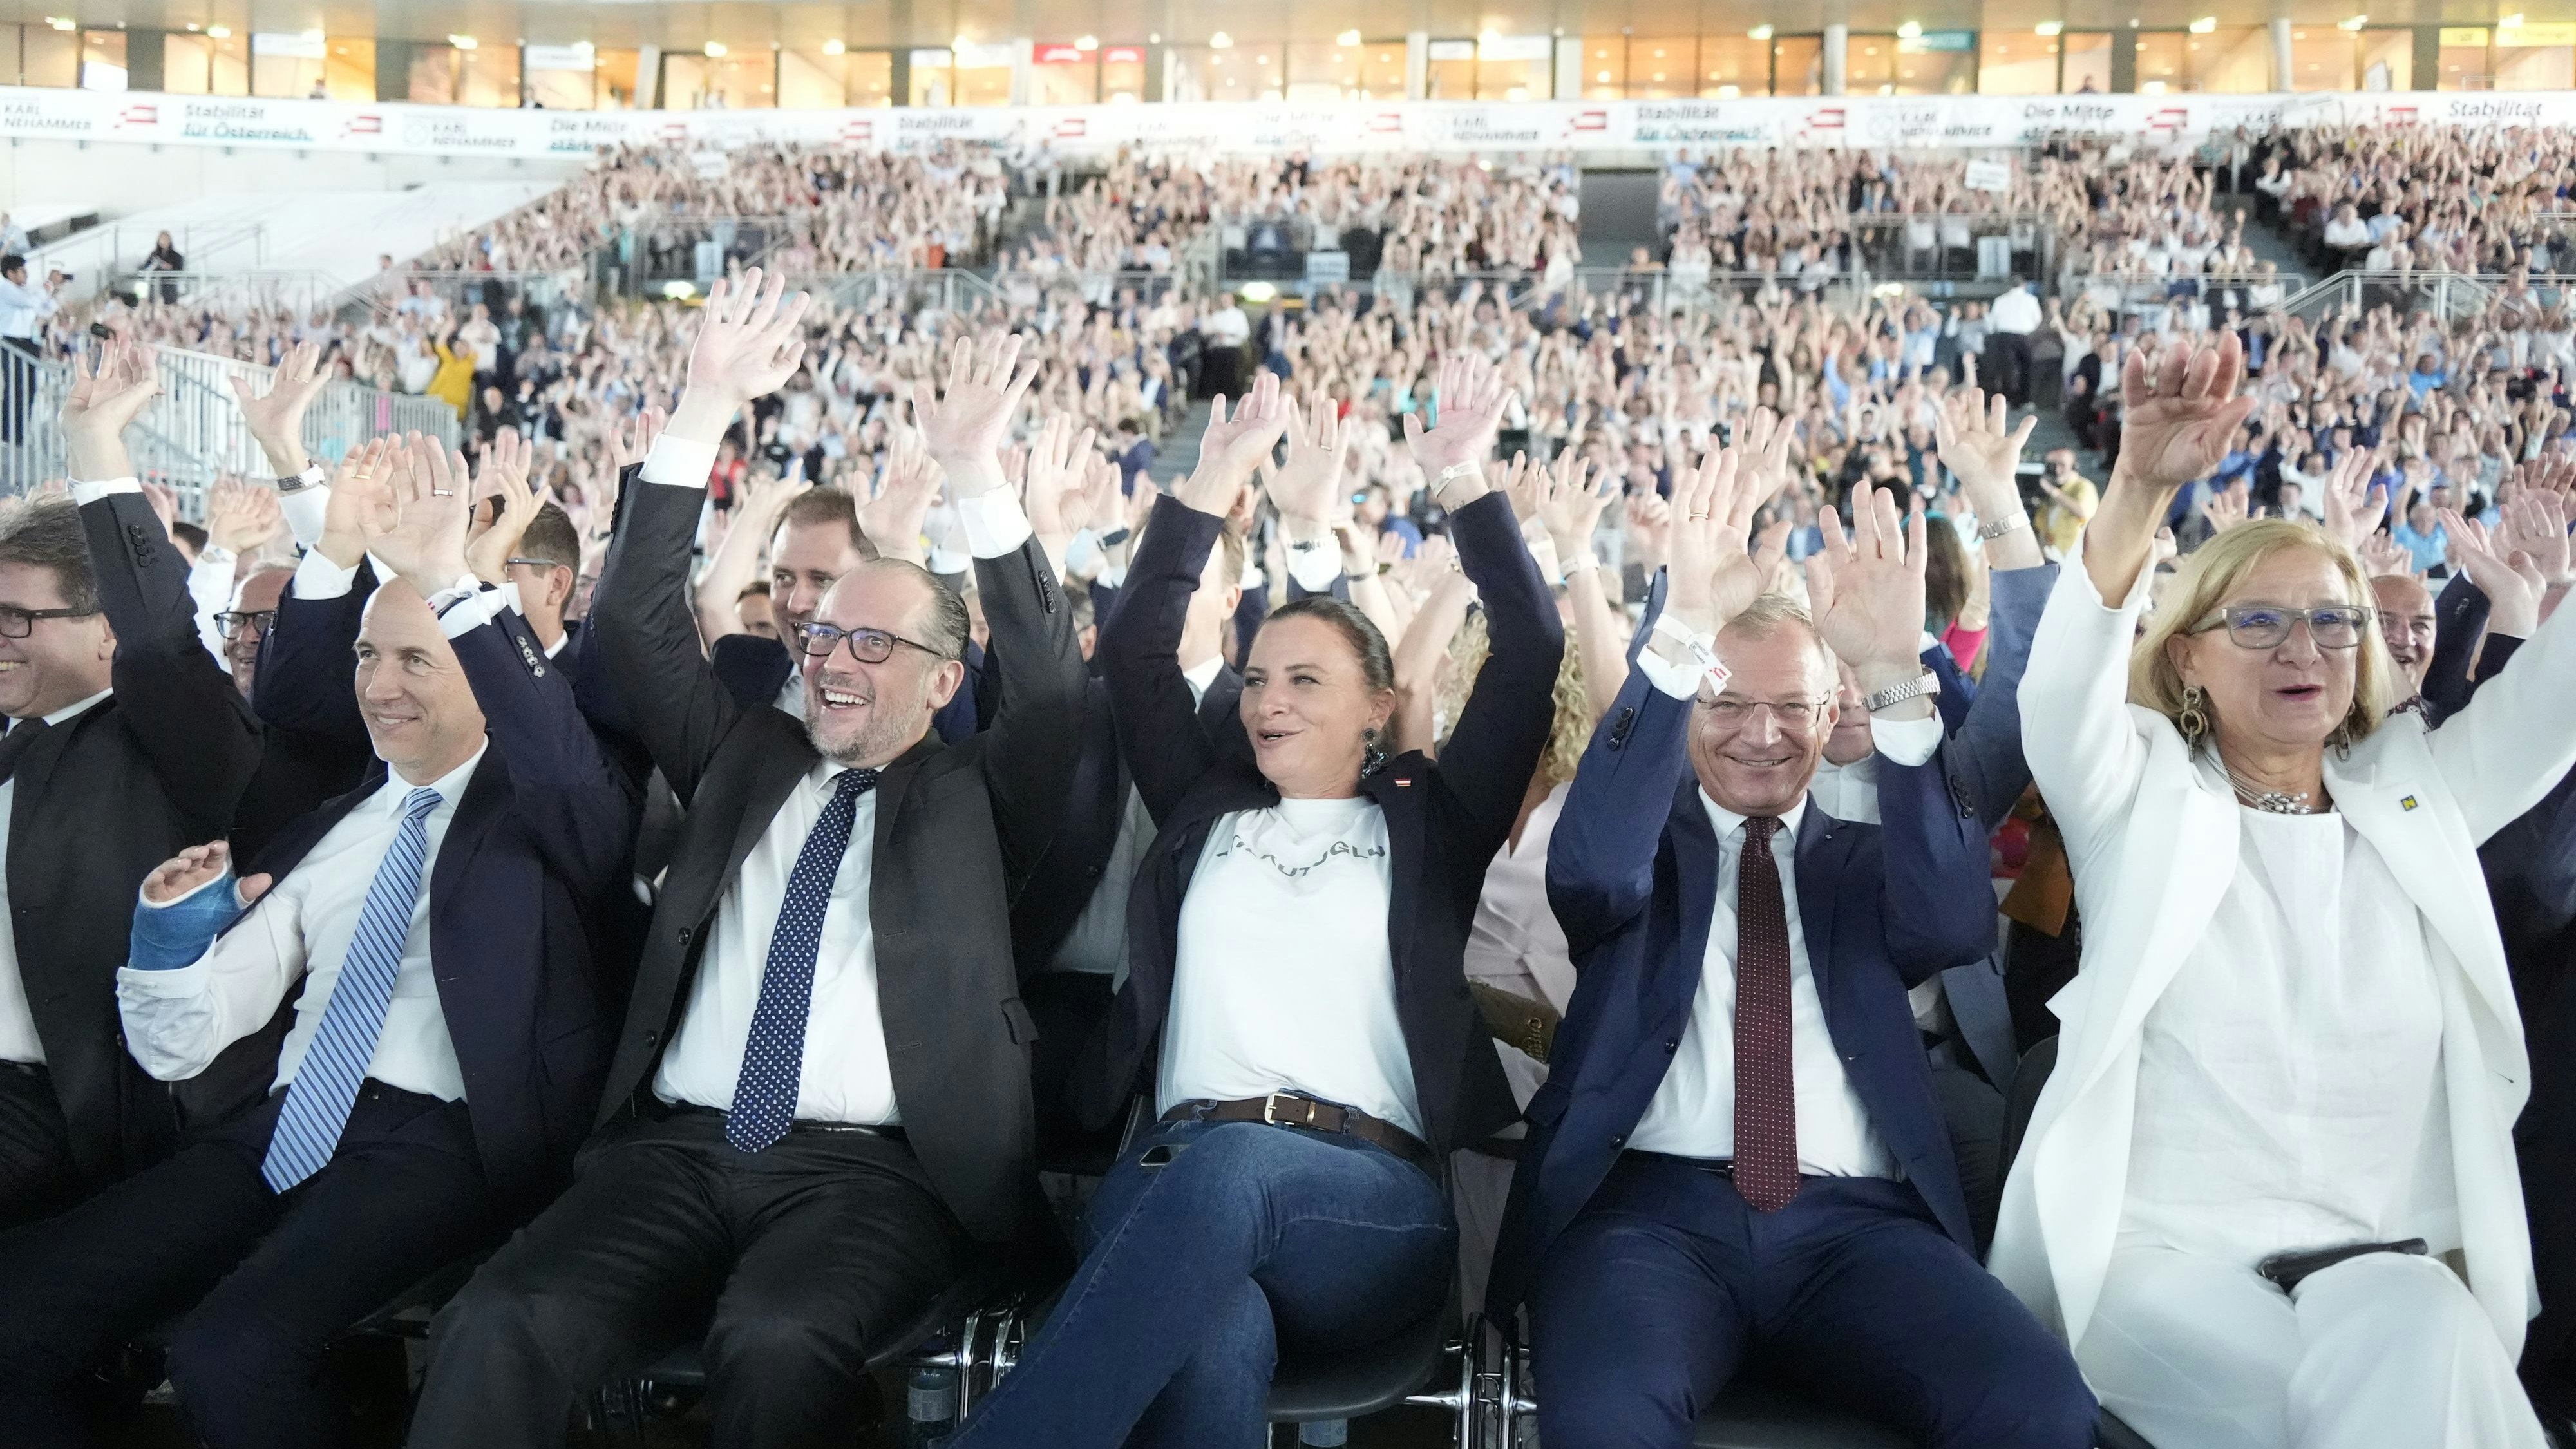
0, 348, 260, 1227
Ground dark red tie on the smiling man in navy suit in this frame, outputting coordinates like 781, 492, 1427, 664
1736, 815, 1798, 1212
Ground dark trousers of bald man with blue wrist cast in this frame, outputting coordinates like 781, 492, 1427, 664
0, 1080, 502, 1449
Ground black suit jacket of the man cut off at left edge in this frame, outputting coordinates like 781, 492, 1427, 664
8, 493, 260, 1186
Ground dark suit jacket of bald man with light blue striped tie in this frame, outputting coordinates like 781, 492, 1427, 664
231, 603, 636, 1209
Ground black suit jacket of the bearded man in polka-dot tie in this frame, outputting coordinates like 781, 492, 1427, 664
590, 469, 1082, 1243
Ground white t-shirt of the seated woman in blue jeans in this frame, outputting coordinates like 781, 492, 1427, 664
1157, 794, 1422, 1137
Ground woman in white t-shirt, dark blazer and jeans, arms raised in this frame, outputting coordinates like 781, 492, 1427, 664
951, 353, 1564, 1449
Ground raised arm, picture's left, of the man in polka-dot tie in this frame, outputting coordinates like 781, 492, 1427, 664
590, 268, 806, 804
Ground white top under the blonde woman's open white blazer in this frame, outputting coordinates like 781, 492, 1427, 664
2120, 807, 2460, 1269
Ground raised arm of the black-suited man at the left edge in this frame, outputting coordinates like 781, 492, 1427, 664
62, 340, 260, 840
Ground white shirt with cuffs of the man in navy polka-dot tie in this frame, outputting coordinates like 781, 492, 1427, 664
644, 433, 1028, 1127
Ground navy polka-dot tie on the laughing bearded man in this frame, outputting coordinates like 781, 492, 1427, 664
724, 771, 876, 1153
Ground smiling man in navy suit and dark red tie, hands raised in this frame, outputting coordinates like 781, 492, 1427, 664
1486, 469, 2094, 1449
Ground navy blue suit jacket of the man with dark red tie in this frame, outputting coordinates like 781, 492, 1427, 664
1486, 619, 1994, 1318
